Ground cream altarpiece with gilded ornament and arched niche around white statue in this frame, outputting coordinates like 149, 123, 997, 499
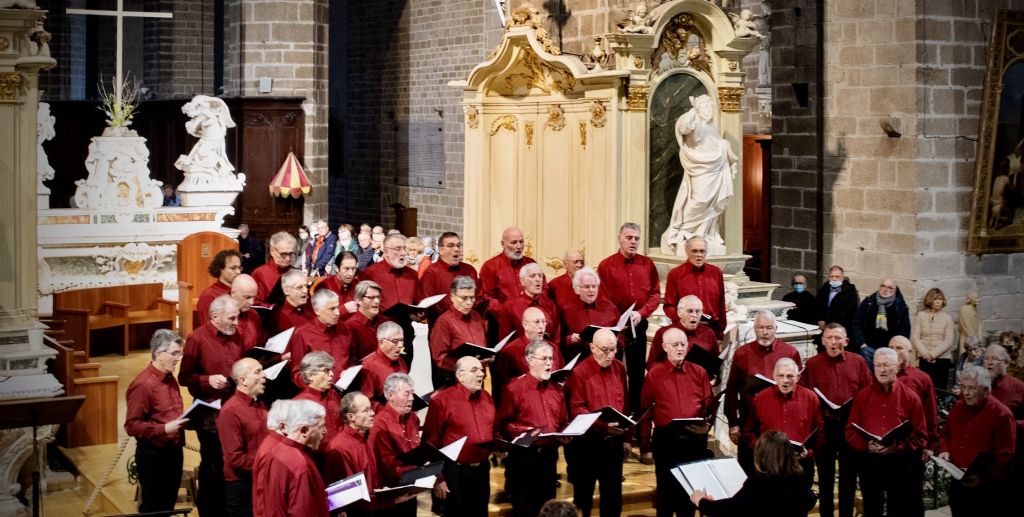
453, 0, 758, 266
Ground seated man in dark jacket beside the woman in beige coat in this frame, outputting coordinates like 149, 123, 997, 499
850, 278, 910, 365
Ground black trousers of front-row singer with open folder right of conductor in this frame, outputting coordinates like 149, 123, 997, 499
857, 451, 921, 517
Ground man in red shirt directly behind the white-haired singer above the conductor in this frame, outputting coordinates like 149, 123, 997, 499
725, 310, 801, 475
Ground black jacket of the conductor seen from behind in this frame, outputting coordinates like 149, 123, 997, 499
698, 474, 817, 517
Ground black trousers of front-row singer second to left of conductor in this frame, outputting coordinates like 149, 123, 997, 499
566, 435, 624, 517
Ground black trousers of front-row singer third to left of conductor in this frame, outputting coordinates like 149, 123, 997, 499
505, 447, 558, 517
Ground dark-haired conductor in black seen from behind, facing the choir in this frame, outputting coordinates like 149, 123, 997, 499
690, 431, 816, 517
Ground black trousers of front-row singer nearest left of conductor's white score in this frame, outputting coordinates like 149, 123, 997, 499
651, 429, 712, 517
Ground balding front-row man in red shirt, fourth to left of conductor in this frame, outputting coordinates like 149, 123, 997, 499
423, 357, 495, 517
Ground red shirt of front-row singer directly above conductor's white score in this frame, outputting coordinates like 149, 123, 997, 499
639, 360, 712, 453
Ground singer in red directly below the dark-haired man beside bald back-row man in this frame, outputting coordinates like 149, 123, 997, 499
430, 276, 487, 384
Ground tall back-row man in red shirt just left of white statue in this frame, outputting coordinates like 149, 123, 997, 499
597, 222, 662, 407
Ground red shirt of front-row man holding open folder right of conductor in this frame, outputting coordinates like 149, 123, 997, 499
846, 382, 928, 453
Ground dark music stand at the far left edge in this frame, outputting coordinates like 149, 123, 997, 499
0, 395, 85, 517
